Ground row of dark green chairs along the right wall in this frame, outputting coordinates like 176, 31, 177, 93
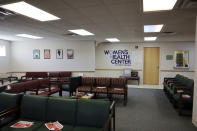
163, 74, 194, 115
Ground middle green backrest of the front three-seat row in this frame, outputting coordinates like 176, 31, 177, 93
46, 97, 76, 125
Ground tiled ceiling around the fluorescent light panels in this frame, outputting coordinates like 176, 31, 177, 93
0, 0, 197, 42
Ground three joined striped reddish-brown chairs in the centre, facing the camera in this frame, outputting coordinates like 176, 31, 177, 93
77, 77, 128, 105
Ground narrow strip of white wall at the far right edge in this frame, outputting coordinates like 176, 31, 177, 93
192, 19, 197, 127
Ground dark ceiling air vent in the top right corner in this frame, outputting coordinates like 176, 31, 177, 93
175, 0, 197, 9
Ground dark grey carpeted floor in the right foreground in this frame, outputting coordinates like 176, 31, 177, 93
116, 88, 197, 131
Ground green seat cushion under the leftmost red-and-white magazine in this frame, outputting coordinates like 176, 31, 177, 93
0, 119, 43, 131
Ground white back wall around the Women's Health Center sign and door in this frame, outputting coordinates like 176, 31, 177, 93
96, 42, 195, 84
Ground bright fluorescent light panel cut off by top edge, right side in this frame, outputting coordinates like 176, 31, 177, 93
143, 0, 177, 12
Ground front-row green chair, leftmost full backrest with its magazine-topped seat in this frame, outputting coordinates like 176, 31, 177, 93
0, 95, 48, 131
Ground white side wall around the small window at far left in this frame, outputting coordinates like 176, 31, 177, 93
0, 40, 10, 73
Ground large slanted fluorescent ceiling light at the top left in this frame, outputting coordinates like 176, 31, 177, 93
0, 1, 60, 21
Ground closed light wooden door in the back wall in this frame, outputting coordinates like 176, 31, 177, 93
144, 47, 160, 85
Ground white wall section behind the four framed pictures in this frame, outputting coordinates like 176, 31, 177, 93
11, 40, 95, 72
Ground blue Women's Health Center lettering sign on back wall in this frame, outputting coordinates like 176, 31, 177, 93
104, 49, 131, 66
